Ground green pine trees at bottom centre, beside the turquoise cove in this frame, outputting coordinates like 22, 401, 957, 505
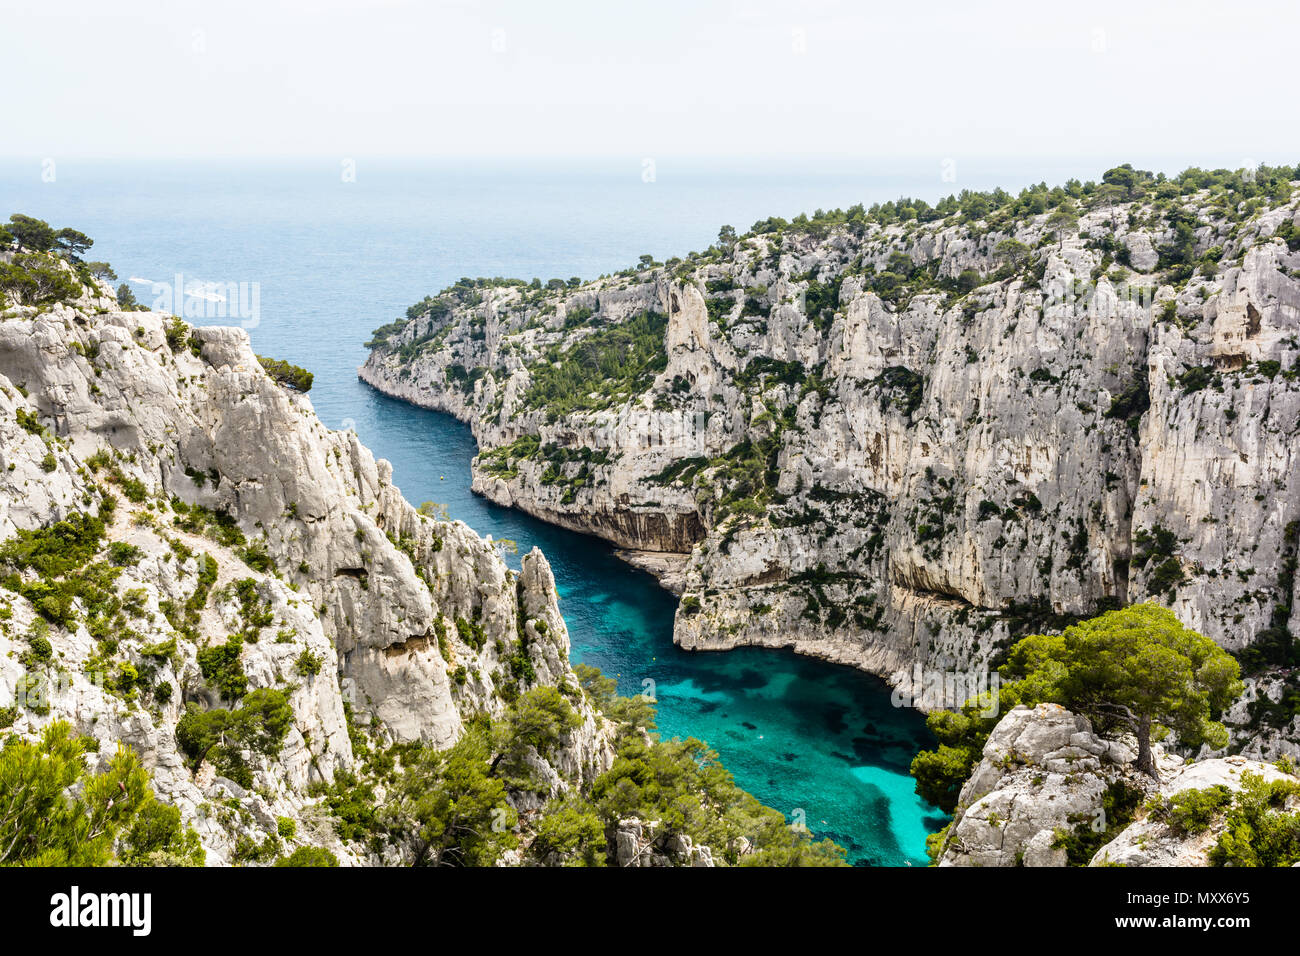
310, 665, 844, 866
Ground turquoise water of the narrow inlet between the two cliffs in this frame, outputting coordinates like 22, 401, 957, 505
345, 392, 944, 865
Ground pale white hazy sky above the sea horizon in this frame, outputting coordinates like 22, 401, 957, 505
0, 0, 1300, 166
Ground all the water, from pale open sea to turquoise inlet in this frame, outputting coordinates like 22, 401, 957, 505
0, 161, 946, 865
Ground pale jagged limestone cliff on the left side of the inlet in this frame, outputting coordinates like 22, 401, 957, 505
0, 290, 612, 864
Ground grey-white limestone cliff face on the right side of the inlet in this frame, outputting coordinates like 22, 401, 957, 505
359, 184, 1300, 754
